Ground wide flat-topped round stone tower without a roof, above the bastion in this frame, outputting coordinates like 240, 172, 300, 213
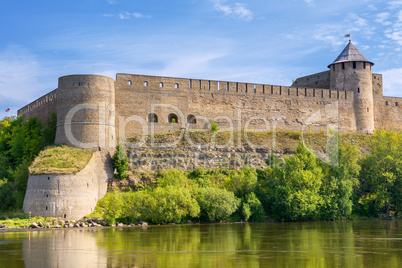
55, 75, 116, 150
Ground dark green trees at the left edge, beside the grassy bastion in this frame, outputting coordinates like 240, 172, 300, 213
0, 113, 57, 211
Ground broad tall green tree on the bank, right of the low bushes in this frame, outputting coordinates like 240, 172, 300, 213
263, 143, 324, 220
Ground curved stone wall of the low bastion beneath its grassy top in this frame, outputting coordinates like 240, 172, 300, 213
24, 151, 113, 220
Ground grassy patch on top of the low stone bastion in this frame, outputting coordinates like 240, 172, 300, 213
29, 145, 93, 175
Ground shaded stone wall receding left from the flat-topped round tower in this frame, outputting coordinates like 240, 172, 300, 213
17, 89, 57, 123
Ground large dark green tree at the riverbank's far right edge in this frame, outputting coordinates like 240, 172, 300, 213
356, 130, 402, 217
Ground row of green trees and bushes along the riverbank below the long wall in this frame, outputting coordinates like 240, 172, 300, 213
102, 130, 402, 223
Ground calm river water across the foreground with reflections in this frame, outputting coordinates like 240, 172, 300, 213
0, 221, 402, 268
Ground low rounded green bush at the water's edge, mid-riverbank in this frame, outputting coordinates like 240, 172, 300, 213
196, 187, 240, 222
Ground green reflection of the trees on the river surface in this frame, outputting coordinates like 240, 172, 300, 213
92, 221, 402, 267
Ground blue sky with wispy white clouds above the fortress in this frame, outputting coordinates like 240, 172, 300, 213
0, 0, 402, 118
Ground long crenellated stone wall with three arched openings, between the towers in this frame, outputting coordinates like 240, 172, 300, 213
116, 74, 356, 139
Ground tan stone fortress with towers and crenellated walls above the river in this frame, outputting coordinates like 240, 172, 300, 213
18, 42, 402, 218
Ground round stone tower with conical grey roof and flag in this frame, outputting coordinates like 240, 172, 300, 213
328, 41, 374, 134
